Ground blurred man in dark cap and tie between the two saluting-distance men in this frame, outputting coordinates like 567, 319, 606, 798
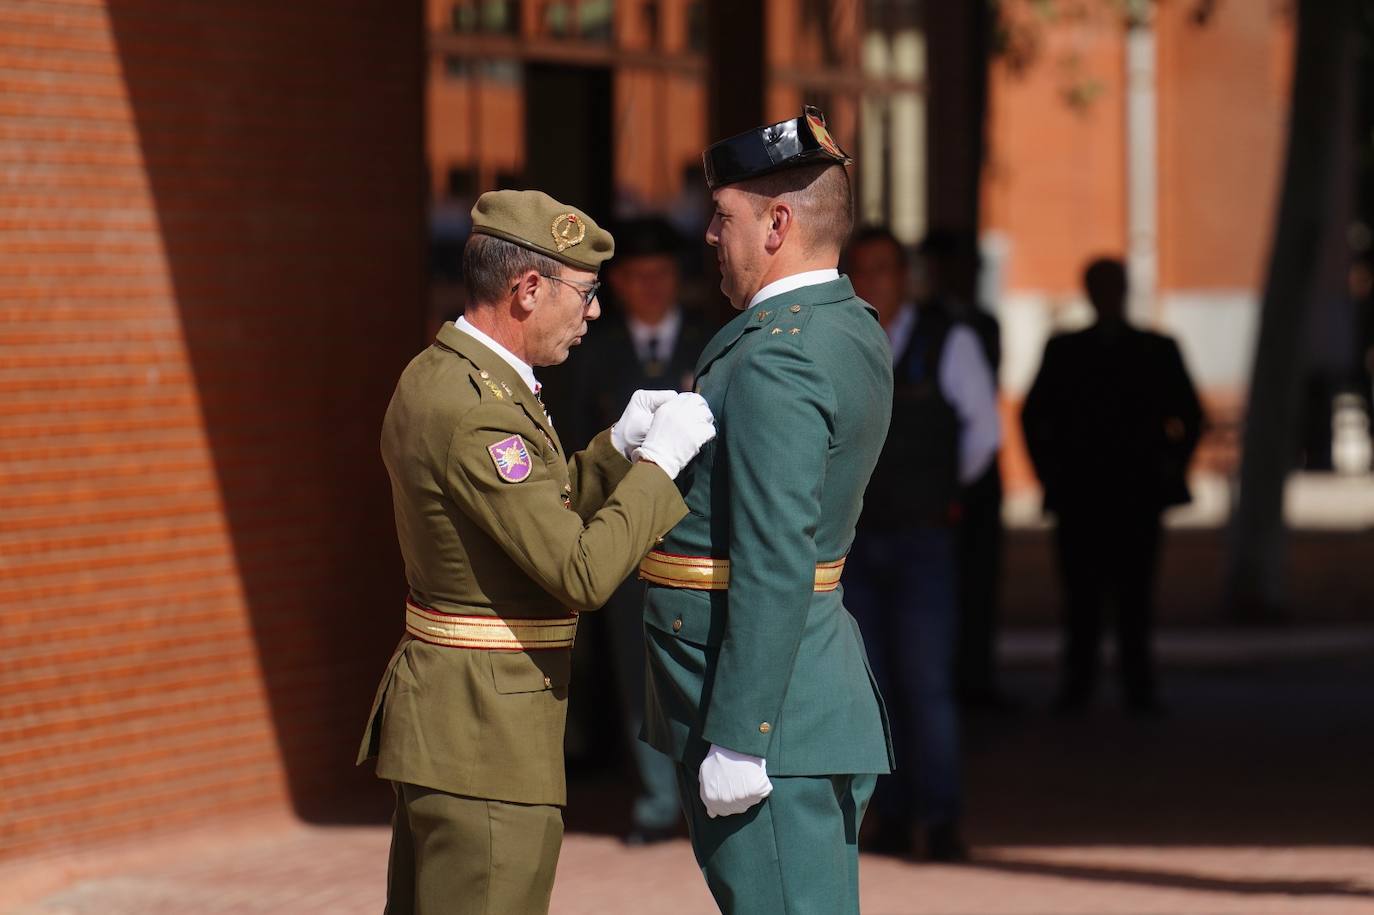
548, 217, 712, 845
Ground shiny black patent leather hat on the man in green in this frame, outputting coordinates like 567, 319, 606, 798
701, 104, 853, 190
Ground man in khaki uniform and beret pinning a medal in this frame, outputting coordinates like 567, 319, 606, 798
359, 191, 714, 915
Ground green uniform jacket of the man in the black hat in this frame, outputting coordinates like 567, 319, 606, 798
644, 276, 892, 776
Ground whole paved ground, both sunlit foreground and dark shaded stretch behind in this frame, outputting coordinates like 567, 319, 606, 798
0, 633, 1374, 915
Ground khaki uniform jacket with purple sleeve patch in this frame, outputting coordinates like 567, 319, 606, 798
359, 324, 686, 805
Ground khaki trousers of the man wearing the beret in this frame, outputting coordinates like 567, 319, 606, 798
386, 783, 563, 915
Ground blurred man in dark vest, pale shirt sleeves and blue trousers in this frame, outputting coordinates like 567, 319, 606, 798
845, 227, 1002, 861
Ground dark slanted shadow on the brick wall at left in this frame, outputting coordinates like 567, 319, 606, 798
109, 0, 425, 820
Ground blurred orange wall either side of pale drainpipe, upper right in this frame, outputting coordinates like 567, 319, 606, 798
982, 0, 1293, 295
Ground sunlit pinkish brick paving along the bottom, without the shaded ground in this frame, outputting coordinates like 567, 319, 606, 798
10, 823, 1374, 915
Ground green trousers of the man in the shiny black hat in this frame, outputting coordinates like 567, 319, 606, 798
677, 764, 878, 915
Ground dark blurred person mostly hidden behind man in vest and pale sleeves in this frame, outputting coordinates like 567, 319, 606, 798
915, 229, 1015, 712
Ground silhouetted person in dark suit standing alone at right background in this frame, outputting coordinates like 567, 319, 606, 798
1021, 258, 1202, 714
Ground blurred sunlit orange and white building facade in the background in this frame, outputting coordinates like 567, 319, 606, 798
427, 0, 1293, 490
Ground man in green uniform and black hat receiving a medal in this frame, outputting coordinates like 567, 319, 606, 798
640, 107, 892, 915
